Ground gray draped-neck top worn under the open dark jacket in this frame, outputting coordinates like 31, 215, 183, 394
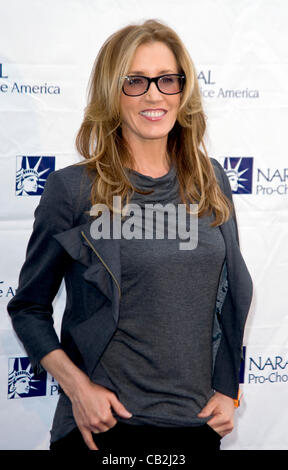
51, 162, 225, 441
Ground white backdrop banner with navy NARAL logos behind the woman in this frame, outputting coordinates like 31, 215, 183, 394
0, 0, 288, 450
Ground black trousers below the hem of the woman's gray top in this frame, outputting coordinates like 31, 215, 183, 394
50, 421, 221, 455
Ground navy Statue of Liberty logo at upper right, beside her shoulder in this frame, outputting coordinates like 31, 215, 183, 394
224, 157, 253, 194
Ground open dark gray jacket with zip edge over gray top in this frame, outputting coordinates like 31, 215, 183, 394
7, 158, 252, 398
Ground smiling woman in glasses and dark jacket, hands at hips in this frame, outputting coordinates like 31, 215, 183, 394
8, 20, 252, 453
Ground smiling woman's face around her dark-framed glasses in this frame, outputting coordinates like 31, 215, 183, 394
120, 41, 181, 147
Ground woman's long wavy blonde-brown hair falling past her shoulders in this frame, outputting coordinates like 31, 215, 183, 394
75, 20, 233, 227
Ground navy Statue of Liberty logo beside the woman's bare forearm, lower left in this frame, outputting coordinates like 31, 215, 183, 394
8, 357, 59, 400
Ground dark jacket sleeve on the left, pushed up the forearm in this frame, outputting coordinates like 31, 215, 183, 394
7, 170, 73, 373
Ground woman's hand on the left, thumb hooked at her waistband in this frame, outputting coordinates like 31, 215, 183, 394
70, 379, 132, 450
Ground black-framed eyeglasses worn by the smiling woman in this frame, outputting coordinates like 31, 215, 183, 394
121, 73, 185, 96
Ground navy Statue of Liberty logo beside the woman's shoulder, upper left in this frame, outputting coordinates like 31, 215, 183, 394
16, 155, 55, 196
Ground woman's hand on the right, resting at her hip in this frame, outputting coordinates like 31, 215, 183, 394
198, 392, 234, 437
